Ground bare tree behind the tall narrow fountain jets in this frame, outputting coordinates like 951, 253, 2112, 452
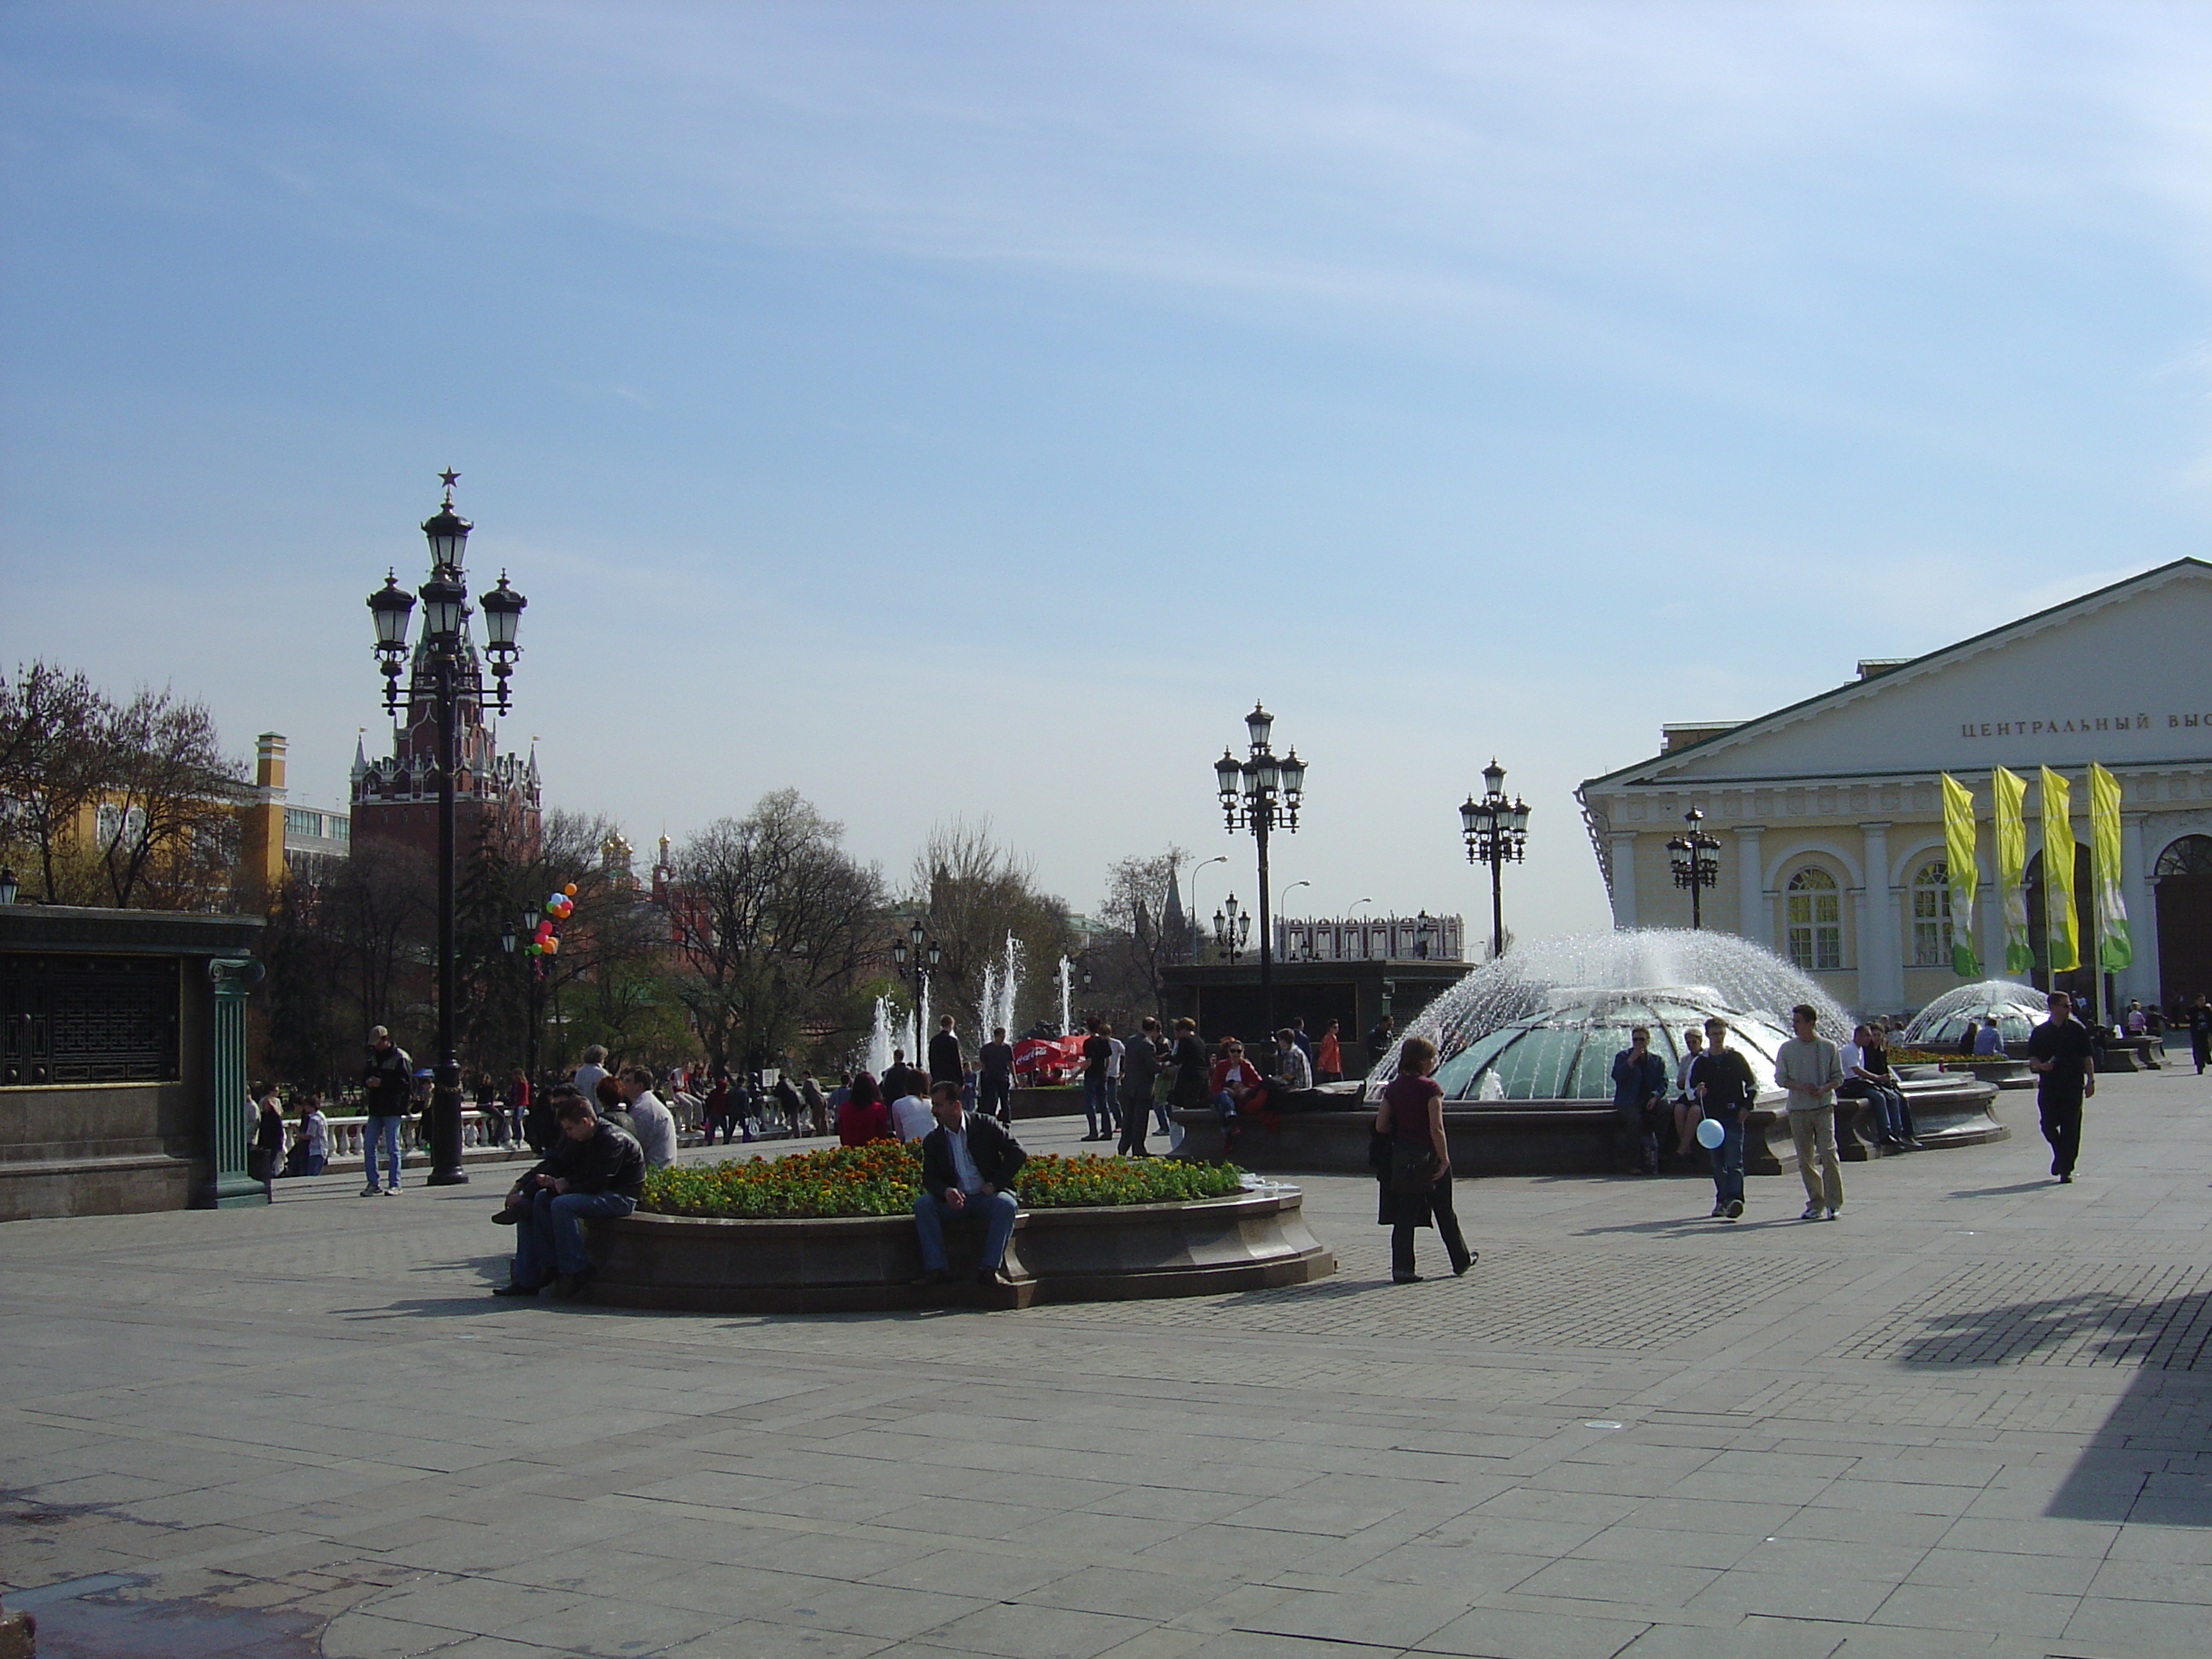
907, 818, 1073, 1039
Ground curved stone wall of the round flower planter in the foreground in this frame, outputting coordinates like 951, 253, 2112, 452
586, 1188, 1336, 1314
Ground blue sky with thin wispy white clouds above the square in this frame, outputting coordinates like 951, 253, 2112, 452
0, 0, 2212, 935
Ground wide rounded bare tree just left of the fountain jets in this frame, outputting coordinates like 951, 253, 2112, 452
670, 789, 882, 1068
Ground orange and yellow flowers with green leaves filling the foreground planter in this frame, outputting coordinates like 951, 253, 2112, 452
637, 1141, 1241, 1219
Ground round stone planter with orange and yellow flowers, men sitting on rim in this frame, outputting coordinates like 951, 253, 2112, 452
586, 1141, 1336, 1314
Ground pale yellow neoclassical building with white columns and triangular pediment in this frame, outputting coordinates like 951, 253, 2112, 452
1577, 560, 2212, 1013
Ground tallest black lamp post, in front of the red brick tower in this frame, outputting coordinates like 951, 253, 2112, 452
370, 469, 527, 1185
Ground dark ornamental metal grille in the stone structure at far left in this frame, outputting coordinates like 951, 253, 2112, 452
0, 952, 179, 1088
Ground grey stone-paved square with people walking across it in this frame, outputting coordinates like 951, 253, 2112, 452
0, 1066, 2212, 1659
